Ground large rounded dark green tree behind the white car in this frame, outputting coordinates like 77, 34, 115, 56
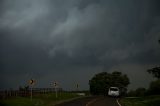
89, 71, 129, 95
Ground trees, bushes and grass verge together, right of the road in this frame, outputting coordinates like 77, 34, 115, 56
120, 67, 160, 106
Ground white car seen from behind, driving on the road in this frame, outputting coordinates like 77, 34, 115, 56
108, 87, 120, 97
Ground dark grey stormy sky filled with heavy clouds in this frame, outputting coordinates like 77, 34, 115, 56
0, 0, 160, 90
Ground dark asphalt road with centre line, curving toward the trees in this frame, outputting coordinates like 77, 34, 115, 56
57, 96, 119, 106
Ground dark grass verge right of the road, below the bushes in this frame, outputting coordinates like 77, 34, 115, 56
120, 95, 160, 106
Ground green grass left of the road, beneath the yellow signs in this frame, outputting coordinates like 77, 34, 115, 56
0, 93, 83, 106
